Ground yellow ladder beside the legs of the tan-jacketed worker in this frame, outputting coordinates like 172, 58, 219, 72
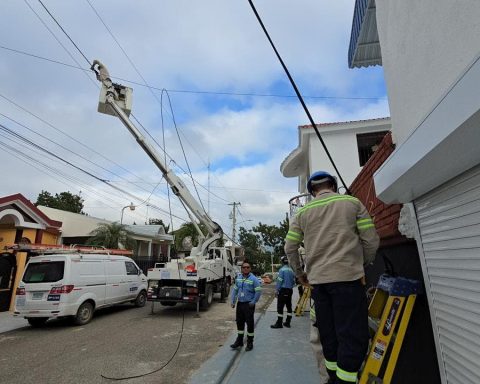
359, 275, 421, 384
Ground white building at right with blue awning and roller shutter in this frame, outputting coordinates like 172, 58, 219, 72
349, 0, 480, 383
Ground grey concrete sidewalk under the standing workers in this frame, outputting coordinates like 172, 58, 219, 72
190, 290, 321, 384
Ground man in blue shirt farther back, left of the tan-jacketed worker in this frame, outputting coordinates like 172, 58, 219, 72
270, 256, 295, 328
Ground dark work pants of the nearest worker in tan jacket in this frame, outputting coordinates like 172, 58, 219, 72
312, 280, 369, 380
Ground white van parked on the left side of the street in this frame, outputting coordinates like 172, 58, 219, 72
14, 253, 147, 327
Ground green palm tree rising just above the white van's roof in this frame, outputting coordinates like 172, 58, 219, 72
87, 223, 135, 249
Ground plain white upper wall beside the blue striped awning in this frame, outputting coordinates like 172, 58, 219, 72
376, 0, 480, 145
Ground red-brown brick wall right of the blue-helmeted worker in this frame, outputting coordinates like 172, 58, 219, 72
350, 133, 407, 246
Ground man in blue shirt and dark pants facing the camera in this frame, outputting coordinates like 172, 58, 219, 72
230, 261, 262, 351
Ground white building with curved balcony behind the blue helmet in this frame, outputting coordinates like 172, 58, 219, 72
280, 117, 390, 193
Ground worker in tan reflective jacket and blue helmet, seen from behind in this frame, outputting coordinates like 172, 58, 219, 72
285, 171, 379, 384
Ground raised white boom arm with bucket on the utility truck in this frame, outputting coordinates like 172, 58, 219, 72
91, 60, 223, 256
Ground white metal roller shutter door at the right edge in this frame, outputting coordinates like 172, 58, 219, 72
414, 166, 480, 384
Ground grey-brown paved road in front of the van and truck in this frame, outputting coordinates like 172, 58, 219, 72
0, 286, 273, 384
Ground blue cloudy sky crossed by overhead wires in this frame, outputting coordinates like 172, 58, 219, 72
0, 0, 389, 237
